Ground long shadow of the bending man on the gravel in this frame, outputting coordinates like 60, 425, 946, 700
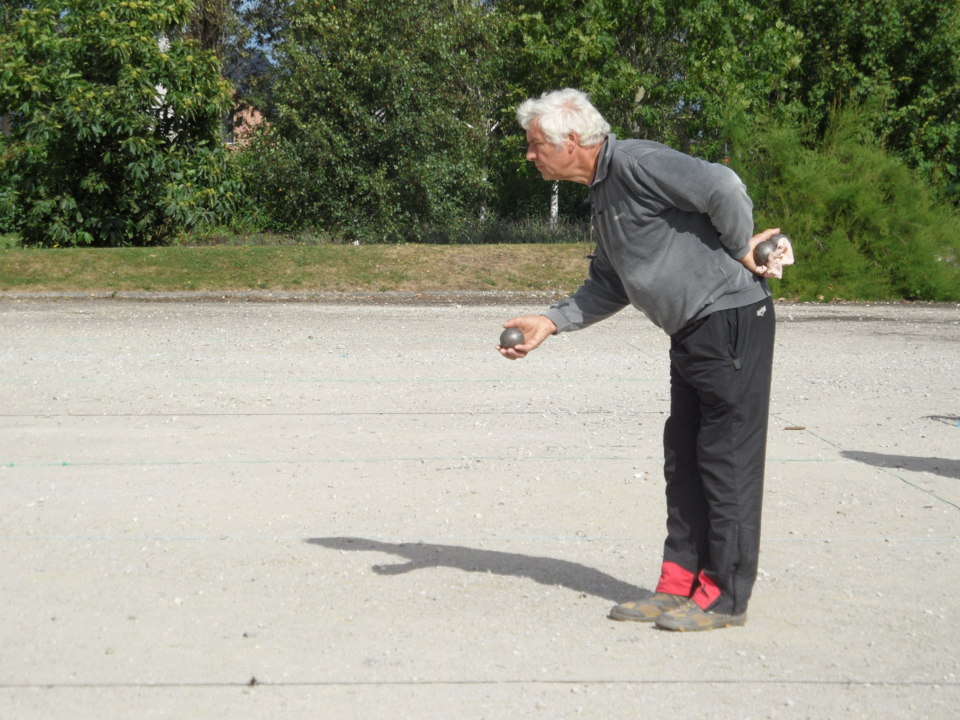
305, 537, 653, 603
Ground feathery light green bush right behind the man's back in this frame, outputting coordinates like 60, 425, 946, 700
733, 108, 960, 301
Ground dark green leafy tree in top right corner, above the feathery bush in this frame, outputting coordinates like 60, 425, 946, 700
778, 0, 960, 205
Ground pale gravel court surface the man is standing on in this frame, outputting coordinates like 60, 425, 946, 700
0, 296, 960, 720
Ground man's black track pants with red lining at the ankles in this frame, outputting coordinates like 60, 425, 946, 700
657, 298, 776, 613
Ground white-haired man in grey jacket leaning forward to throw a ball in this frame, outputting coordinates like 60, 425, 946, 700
498, 89, 778, 630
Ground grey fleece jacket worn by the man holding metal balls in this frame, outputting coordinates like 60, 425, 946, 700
544, 134, 770, 335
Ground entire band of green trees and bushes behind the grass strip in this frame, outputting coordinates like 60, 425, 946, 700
0, 0, 960, 300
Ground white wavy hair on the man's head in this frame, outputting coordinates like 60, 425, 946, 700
517, 88, 610, 147
